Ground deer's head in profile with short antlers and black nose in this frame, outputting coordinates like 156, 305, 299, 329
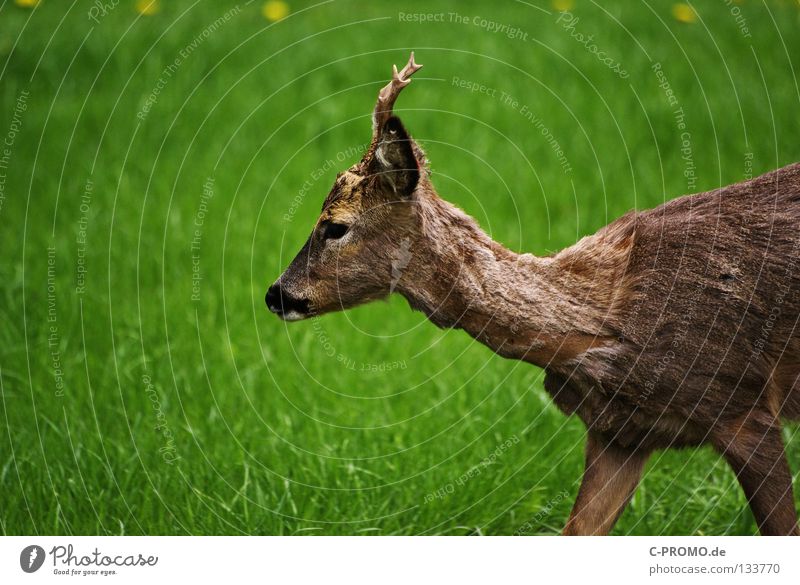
265, 53, 427, 321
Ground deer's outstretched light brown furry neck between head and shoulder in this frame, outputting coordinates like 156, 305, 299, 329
397, 198, 620, 367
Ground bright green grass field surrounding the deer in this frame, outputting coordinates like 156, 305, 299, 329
0, 0, 800, 534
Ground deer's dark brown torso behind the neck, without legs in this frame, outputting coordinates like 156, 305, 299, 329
548, 164, 800, 444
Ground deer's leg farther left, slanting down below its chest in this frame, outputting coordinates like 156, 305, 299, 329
564, 431, 650, 535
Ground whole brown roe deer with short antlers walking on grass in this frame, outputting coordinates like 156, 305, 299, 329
265, 52, 800, 535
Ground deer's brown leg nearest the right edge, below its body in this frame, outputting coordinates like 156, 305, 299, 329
714, 413, 798, 536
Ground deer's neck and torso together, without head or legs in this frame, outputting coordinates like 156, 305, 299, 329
399, 164, 800, 448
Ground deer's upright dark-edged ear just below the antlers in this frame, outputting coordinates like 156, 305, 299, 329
369, 116, 419, 197
